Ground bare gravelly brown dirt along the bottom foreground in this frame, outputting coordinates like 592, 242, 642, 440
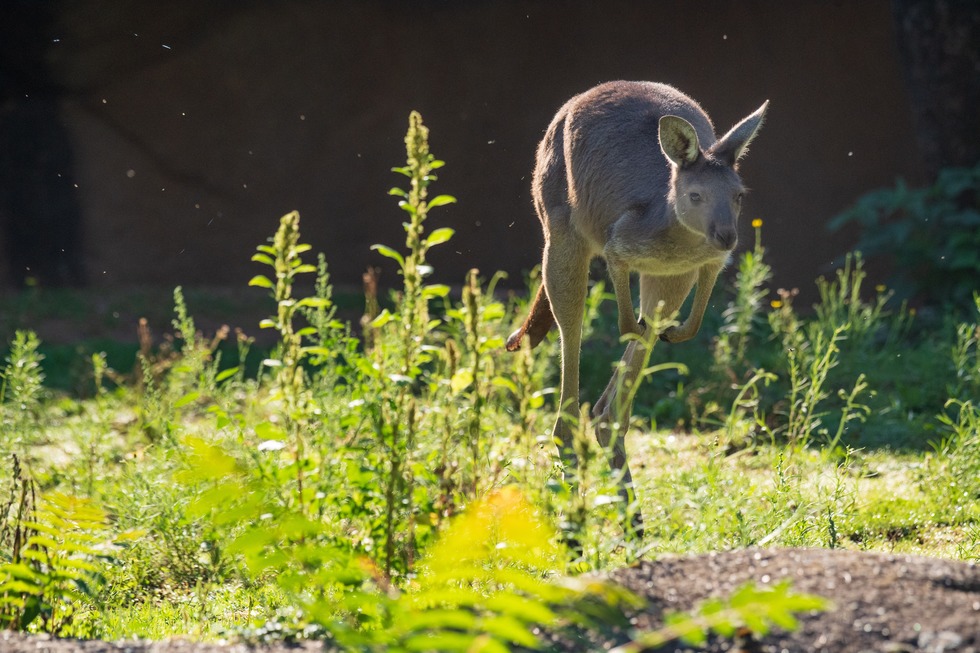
0, 549, 980, 653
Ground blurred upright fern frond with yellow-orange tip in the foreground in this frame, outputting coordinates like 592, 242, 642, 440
382, 488, 578, 651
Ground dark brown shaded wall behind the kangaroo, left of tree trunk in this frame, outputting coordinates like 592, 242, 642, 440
0, 0, 972, 300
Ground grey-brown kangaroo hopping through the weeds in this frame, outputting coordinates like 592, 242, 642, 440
507, 81, 769, 530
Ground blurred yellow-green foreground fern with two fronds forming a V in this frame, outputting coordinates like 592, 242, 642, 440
179, 432, 636, 651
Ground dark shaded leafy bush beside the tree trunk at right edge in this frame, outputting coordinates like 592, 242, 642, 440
829, 165, 980, 309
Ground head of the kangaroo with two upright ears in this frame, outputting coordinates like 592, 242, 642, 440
659, 101, 769, 250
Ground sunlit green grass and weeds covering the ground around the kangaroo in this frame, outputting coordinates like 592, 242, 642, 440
0, 114, 980, 650
